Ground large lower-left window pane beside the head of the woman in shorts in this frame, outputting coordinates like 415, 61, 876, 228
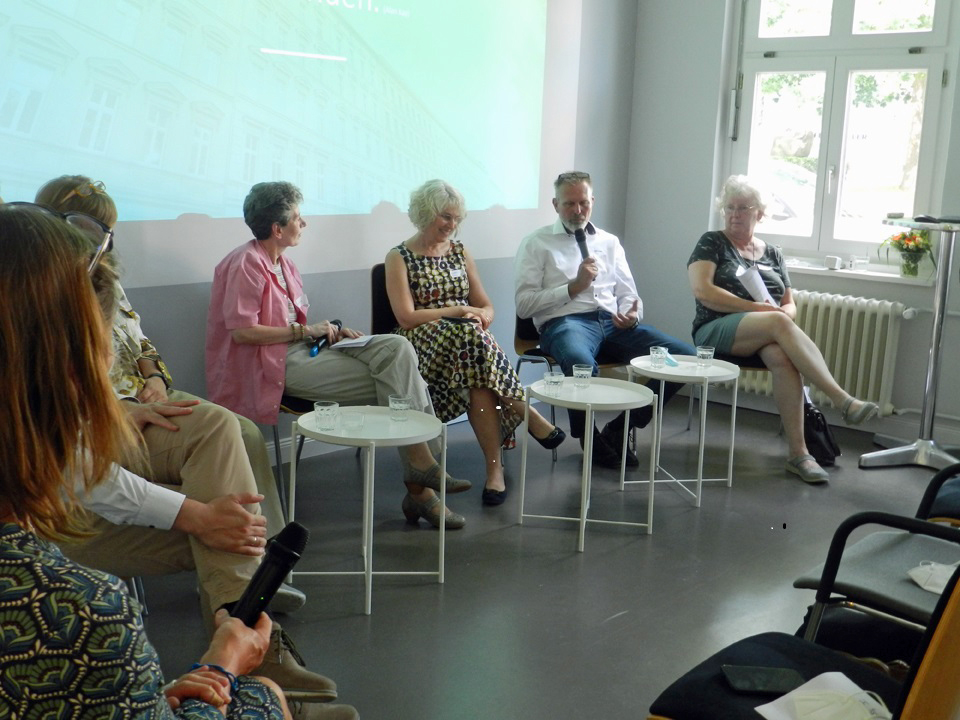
747, 72, 827, 237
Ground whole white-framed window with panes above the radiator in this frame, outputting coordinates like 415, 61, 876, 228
730, 0, 948, 255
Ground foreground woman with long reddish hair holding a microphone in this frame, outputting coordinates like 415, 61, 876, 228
0, 206, 290, 720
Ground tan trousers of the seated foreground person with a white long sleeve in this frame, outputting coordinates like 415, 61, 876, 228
60, 392, 262, 614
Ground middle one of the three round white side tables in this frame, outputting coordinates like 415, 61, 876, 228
519, 377, 660, 552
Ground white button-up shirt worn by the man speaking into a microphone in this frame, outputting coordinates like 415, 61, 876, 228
514, 218, 643, 330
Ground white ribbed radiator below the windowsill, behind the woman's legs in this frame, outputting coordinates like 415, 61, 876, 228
740, 290, 904, 415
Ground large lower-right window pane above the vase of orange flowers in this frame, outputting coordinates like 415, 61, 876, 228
834, 70, 927, 242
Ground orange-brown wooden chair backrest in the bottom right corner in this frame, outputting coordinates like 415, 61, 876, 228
893, 568, 960, 720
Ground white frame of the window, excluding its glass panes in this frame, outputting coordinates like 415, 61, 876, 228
727, 0, 951, 256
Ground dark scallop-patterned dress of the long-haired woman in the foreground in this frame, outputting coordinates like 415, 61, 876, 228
0, 523, 283, 720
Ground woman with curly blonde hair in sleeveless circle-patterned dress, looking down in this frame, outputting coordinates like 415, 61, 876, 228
385, 180, 566, 505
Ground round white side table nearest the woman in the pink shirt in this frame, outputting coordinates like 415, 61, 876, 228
287, 405, 447, 615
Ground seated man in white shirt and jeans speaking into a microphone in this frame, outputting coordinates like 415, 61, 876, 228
515, 172, 696, 468
